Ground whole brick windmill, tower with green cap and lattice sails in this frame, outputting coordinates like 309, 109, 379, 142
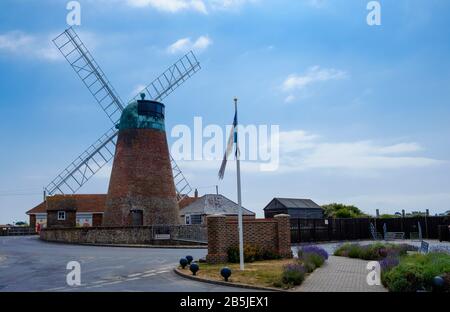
45, 28, 200, 226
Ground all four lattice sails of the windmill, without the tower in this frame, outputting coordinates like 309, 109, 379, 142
45, 27, 200, 207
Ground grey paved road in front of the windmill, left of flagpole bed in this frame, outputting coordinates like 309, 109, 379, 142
0, 237, 246, 292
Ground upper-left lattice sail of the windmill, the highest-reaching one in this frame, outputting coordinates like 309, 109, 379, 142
53, 27, 124, 124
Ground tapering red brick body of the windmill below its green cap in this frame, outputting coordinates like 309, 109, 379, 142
103, 129, 179, 226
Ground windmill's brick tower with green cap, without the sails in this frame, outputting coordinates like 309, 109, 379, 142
103, 93, 179, 225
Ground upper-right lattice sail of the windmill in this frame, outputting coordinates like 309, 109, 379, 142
130, 51, 201, 102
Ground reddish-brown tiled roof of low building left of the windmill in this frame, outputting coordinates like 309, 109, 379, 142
27, 194, 106, 214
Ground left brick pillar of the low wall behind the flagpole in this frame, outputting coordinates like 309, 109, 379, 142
206, 215, 228, 264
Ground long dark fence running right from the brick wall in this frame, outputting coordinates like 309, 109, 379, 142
291, 216, 450, 244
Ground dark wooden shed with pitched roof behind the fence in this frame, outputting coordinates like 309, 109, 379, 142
264, 197, 323, 219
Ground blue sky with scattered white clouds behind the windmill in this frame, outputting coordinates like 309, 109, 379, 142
0, 0, 450, 224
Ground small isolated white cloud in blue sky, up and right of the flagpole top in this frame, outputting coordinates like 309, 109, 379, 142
281, 66, 348, 92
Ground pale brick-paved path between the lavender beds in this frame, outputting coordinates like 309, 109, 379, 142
294, 256, 387, 292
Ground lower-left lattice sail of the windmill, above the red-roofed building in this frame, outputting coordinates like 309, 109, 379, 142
45, 127, 118, 195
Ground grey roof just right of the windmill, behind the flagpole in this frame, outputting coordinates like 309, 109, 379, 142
181, 194, 255, 216
